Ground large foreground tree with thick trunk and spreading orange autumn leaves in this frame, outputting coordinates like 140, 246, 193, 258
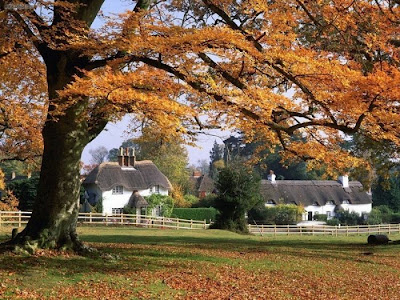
0, 0, 400, 250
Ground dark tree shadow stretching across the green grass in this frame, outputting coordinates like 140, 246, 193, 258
0, 232, 400, 281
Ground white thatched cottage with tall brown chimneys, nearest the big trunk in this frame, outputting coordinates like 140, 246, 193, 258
83, 148, 172, 215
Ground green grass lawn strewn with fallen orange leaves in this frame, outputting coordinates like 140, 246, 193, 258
0, 227, 400, 300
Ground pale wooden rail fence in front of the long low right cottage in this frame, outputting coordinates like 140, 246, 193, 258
249, 224, 400, 236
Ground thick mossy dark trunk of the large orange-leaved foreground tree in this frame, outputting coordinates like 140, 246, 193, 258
11, 51, 94, 253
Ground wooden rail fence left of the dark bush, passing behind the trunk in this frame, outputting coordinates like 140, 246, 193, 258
0, 211, 210, 229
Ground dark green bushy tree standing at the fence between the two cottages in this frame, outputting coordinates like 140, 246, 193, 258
212, 166, 262, 233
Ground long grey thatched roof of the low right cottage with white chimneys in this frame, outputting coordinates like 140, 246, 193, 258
261, 180, 372, 206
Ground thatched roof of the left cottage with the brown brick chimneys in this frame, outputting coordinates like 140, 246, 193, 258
83, 160, 172, 191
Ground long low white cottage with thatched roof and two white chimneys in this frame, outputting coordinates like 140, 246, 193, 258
261, 173, 372, 221
